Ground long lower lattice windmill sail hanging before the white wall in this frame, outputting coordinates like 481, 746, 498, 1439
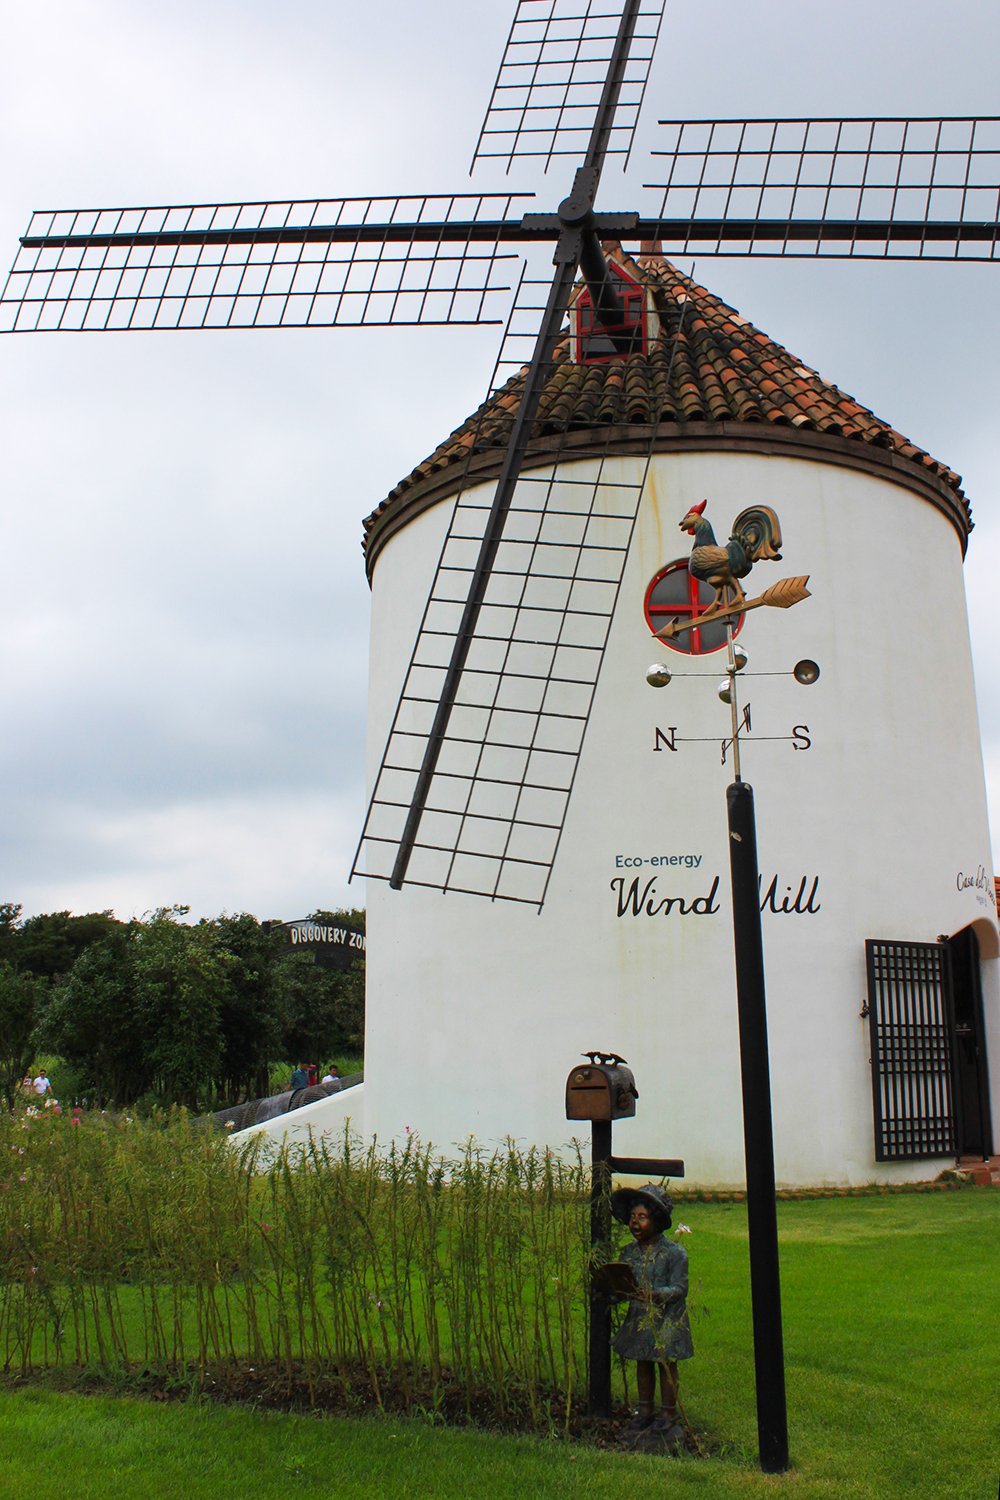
351, 268, 687, 909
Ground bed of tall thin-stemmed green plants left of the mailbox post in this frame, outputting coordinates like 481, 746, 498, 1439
0, 1109, 589, 1425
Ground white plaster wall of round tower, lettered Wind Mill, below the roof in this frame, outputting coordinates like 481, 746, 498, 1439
364, 453, 1000, 1185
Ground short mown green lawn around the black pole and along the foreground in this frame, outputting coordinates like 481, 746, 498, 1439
0, 1190, 1000, 1500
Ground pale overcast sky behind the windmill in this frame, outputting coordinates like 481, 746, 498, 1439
0, 0, 1000, 918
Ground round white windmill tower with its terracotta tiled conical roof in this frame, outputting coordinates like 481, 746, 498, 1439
355, 245, 1000, 1184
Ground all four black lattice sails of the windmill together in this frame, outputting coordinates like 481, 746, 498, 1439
0, 0, 1000, 1470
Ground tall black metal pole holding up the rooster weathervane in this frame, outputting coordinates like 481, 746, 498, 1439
726, 782, 789, 1475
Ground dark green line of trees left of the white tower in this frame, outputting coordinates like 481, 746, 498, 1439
0, 902, 364, 1110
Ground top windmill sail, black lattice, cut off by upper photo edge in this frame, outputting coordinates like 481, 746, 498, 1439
472, 0, 663, 171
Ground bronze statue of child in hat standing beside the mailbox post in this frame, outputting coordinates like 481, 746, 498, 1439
612, 1182, 694, 1451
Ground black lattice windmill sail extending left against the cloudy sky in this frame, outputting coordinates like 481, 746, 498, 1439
0, 194, 530, 333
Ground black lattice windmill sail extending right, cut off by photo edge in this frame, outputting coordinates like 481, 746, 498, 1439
649, 117, 1000, 261
